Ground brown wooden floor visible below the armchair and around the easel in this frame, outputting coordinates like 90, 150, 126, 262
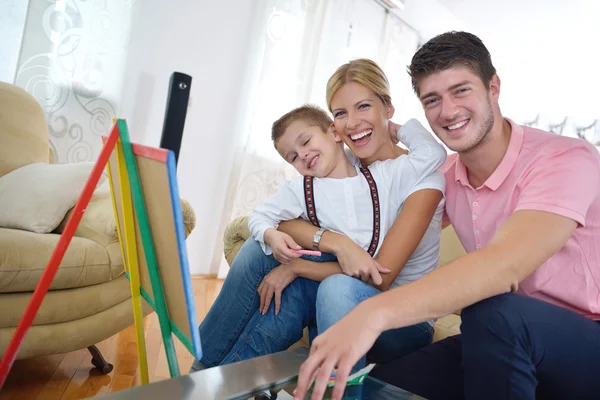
0, 278, 223, 400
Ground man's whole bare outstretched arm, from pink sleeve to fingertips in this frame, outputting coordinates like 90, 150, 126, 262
295, 210, 577, 398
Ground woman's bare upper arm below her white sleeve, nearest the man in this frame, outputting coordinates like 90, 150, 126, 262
369, 189, 442, 291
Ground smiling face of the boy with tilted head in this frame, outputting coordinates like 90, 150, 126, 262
275, 120, 345, 178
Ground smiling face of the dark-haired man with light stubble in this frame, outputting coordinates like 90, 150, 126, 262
419, 66, 500, 153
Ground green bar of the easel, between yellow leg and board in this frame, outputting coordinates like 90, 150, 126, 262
117, 119, 179, 378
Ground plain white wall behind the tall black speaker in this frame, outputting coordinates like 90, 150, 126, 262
118, 0, 255, 274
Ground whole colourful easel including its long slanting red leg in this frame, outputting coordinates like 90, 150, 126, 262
0, 120, 202, 390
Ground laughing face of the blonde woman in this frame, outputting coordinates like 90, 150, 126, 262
331, 82, 394, 160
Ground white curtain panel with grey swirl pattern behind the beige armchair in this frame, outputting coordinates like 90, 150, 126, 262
14, 0, 135, 163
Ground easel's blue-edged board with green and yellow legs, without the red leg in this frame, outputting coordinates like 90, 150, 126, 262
108, 120, 202, 383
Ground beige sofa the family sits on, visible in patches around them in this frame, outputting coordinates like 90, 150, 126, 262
223, 217, 465, 347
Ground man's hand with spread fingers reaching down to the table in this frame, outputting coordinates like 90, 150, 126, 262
294, 300, 382, 399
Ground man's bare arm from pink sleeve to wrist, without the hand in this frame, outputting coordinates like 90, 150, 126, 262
366, 210, 577, 330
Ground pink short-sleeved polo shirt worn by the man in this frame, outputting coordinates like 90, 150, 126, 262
442, 119, 600, 320
